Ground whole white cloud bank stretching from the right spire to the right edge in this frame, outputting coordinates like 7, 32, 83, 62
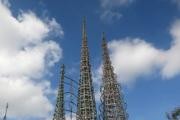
97, 20, 180, 84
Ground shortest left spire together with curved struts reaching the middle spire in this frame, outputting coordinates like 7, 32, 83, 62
53, 65, 82, 120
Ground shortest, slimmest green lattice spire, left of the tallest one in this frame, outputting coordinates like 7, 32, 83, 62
53, 65, 65, 120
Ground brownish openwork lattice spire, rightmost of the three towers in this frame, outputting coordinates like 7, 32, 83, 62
101, 33, 127, 120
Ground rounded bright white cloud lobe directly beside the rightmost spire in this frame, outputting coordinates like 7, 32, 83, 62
108, 38, 162, 83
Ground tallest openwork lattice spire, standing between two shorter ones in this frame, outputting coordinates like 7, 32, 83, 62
77, 18, 97, 120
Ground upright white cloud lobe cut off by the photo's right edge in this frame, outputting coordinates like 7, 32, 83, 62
162, 20, 180, 78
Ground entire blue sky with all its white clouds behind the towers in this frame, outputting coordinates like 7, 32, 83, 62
0, 0, 180, 120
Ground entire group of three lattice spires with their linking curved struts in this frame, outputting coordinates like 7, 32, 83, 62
53, 18, 128, 120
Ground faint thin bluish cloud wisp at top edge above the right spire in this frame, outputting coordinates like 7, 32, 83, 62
100, 0, 134, 23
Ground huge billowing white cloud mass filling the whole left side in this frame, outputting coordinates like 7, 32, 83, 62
0, 0, 64, 120
